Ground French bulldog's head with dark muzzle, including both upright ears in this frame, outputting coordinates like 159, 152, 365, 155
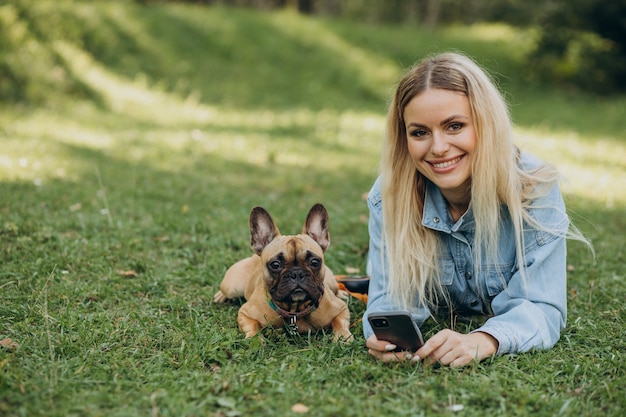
250, 204, 330, 311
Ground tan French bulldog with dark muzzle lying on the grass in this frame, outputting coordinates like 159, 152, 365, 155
213, 204, 352, 341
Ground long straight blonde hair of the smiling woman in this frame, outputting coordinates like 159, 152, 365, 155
381, 53, 584, 308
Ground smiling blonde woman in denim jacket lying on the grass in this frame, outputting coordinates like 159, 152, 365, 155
363, 53, 584, 367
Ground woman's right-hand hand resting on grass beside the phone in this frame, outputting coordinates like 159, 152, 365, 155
415, 329, 498, 368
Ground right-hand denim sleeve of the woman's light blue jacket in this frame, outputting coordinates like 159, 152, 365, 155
475, 181, 569, 354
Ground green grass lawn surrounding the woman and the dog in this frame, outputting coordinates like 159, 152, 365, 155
0, 1, 626, 417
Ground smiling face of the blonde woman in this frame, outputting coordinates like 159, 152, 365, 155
404, 89, 476, 202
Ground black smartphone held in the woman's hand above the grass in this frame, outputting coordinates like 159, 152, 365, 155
367, 311, 424, 352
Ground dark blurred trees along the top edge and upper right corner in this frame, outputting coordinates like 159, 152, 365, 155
145, 0, 626, 94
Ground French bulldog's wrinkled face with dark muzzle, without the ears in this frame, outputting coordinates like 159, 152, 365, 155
261, 235, 324, 311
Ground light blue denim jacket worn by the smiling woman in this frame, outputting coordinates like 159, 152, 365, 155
363, 154, 569, 354
